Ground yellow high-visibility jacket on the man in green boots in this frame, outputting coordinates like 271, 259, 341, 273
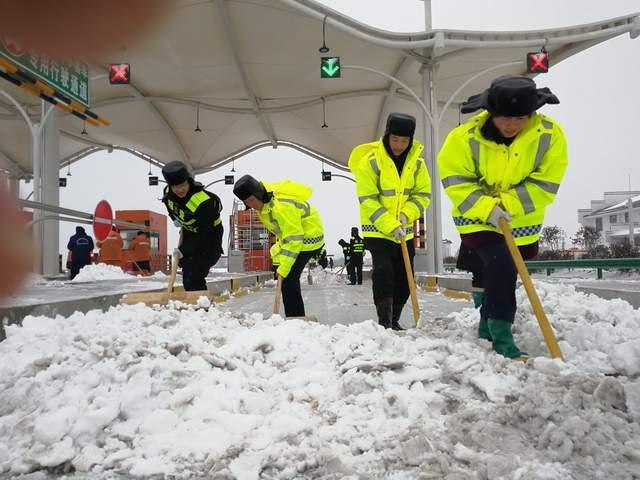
438, 111, 568, 245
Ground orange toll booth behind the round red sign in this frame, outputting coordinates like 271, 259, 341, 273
115, 210, 171, 272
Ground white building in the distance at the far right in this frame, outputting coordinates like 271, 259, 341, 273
578, 191, 640, 245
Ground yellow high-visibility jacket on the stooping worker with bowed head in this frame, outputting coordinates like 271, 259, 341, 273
257, 180, 324, 277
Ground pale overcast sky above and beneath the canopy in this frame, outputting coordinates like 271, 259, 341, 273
31, 0, 640, 260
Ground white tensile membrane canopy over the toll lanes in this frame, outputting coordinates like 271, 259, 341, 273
0, 0, 640, 265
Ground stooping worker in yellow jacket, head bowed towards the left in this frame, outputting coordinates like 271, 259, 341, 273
233, 175, 324, 317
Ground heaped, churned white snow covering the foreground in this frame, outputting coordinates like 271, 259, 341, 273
0, 278, 640, 480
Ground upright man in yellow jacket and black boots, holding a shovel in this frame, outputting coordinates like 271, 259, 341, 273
349, 113, 431, 330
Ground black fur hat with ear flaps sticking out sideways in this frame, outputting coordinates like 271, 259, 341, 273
460, 75, 560, 117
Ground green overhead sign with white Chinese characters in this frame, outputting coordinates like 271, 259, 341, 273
0, 37, 91, 108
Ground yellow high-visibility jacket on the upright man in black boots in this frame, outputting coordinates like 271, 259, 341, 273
349, 139, 431, 243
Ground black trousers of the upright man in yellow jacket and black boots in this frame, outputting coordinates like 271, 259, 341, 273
371, 242, 416, 305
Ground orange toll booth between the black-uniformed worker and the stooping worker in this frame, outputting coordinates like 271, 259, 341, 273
229, 200, 275, 272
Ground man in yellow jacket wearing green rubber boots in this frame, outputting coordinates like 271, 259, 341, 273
438, 75, 568, 359
